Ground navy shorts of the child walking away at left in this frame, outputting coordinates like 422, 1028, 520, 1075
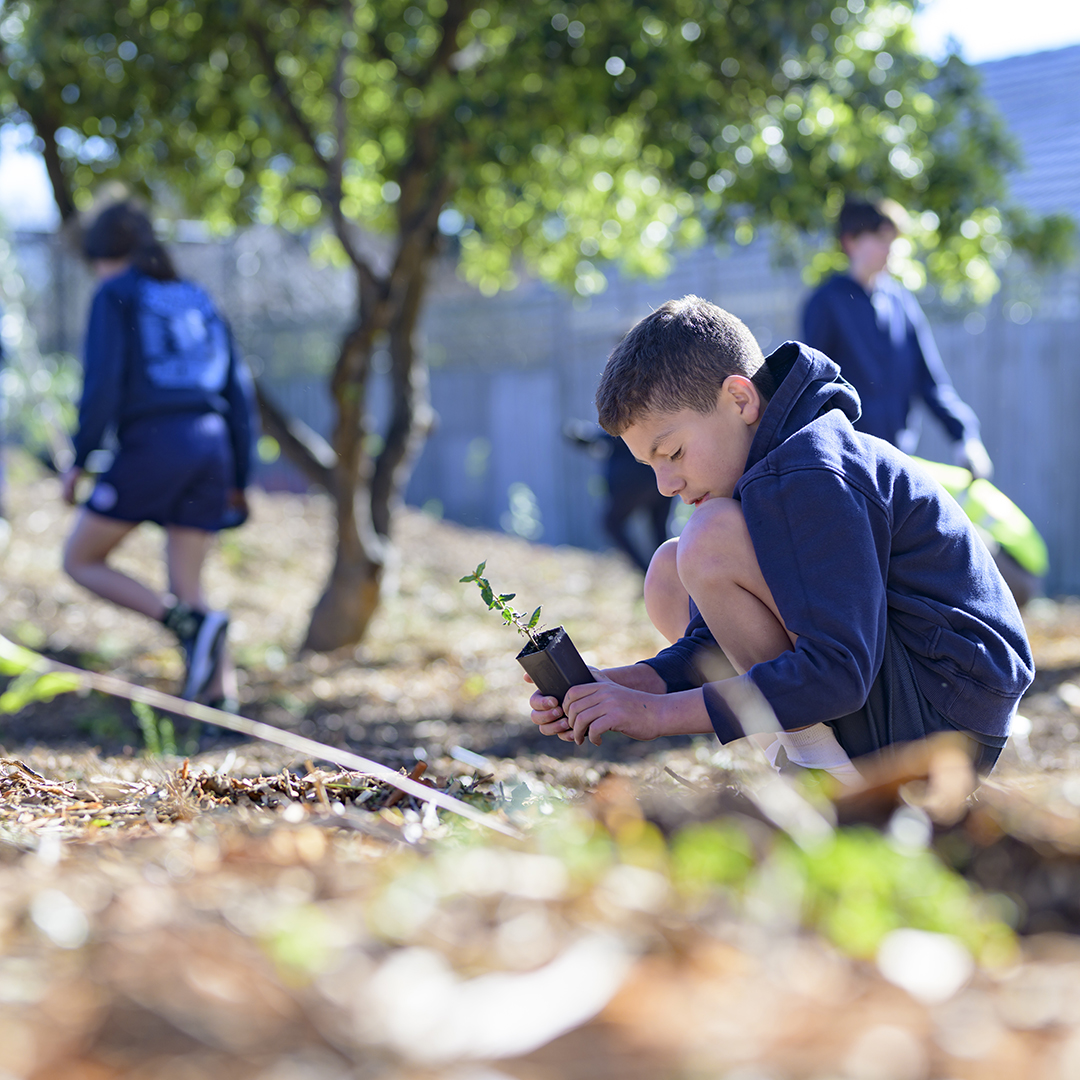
86, 413, 234, 532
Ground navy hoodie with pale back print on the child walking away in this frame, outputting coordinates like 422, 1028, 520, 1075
75, 267, 253, 488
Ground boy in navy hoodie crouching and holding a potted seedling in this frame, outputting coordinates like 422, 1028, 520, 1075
531, 297, 1034, 779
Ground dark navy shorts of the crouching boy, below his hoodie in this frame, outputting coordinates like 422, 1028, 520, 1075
826, 630, 1007, 777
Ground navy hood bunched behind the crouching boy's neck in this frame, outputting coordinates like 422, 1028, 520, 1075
746, 341, 862, 470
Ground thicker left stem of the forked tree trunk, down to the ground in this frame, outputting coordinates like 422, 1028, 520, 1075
301, 312, 386, 652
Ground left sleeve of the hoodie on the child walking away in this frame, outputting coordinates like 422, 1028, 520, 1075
73, 288, 129, 469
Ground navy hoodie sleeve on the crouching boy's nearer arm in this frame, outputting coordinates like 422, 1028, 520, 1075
705, 467, 891, 742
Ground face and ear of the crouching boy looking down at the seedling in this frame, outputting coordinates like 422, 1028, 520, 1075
622, 375, 765, 507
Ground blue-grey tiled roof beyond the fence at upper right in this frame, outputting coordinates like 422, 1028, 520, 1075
978, 45, 1080, 221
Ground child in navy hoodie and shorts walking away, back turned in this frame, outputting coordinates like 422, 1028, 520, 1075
63, 203, 253, 706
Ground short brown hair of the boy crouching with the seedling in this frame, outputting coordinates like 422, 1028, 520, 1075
596, 296, 771, 435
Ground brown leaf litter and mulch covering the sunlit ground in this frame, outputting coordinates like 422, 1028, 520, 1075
0, 460, 1080, 1080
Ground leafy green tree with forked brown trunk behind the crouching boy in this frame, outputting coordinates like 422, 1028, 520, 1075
0, 0, 1062, 648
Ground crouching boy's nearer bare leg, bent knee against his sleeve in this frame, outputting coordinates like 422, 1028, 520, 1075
661, 498, 796, 673
